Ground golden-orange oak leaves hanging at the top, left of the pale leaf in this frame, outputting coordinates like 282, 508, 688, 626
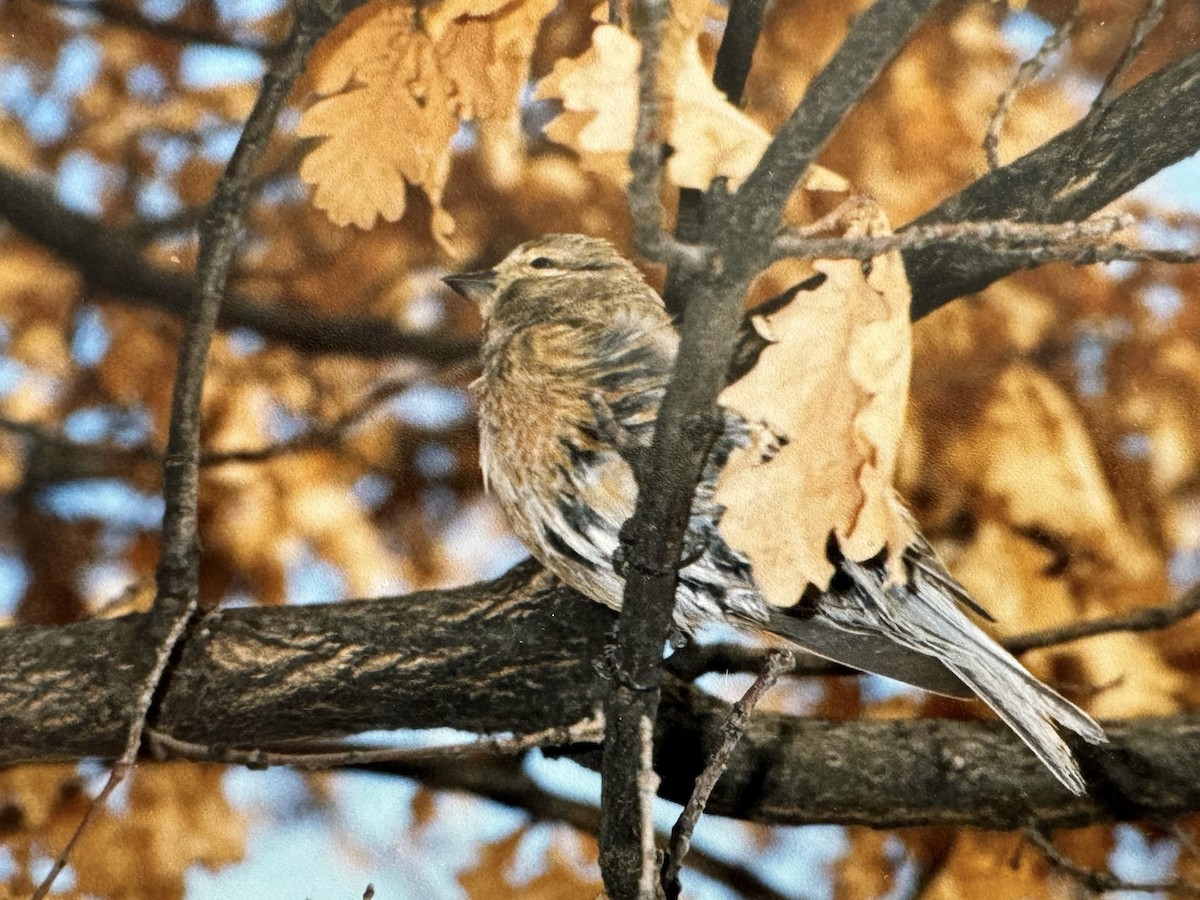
298, 0, 553, 248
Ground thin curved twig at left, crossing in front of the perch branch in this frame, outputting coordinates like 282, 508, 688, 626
34, 8, 332, 900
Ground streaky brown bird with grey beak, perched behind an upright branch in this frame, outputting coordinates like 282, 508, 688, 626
444, 234, 1106, 794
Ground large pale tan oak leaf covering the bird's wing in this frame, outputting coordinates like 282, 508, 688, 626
715, 200, 913, 606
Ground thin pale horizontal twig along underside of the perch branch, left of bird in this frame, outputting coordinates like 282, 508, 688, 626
146, 715, 604, 769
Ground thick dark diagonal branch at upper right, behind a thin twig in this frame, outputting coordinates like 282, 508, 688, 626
901, 52, 1200, 319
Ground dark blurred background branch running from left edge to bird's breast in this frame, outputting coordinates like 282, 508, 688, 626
0, 166, 476, 362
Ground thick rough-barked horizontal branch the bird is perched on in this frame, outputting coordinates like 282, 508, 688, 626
0, 571, 1200, 829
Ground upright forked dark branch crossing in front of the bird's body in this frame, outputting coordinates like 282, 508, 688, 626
600, 0, 937, 900
